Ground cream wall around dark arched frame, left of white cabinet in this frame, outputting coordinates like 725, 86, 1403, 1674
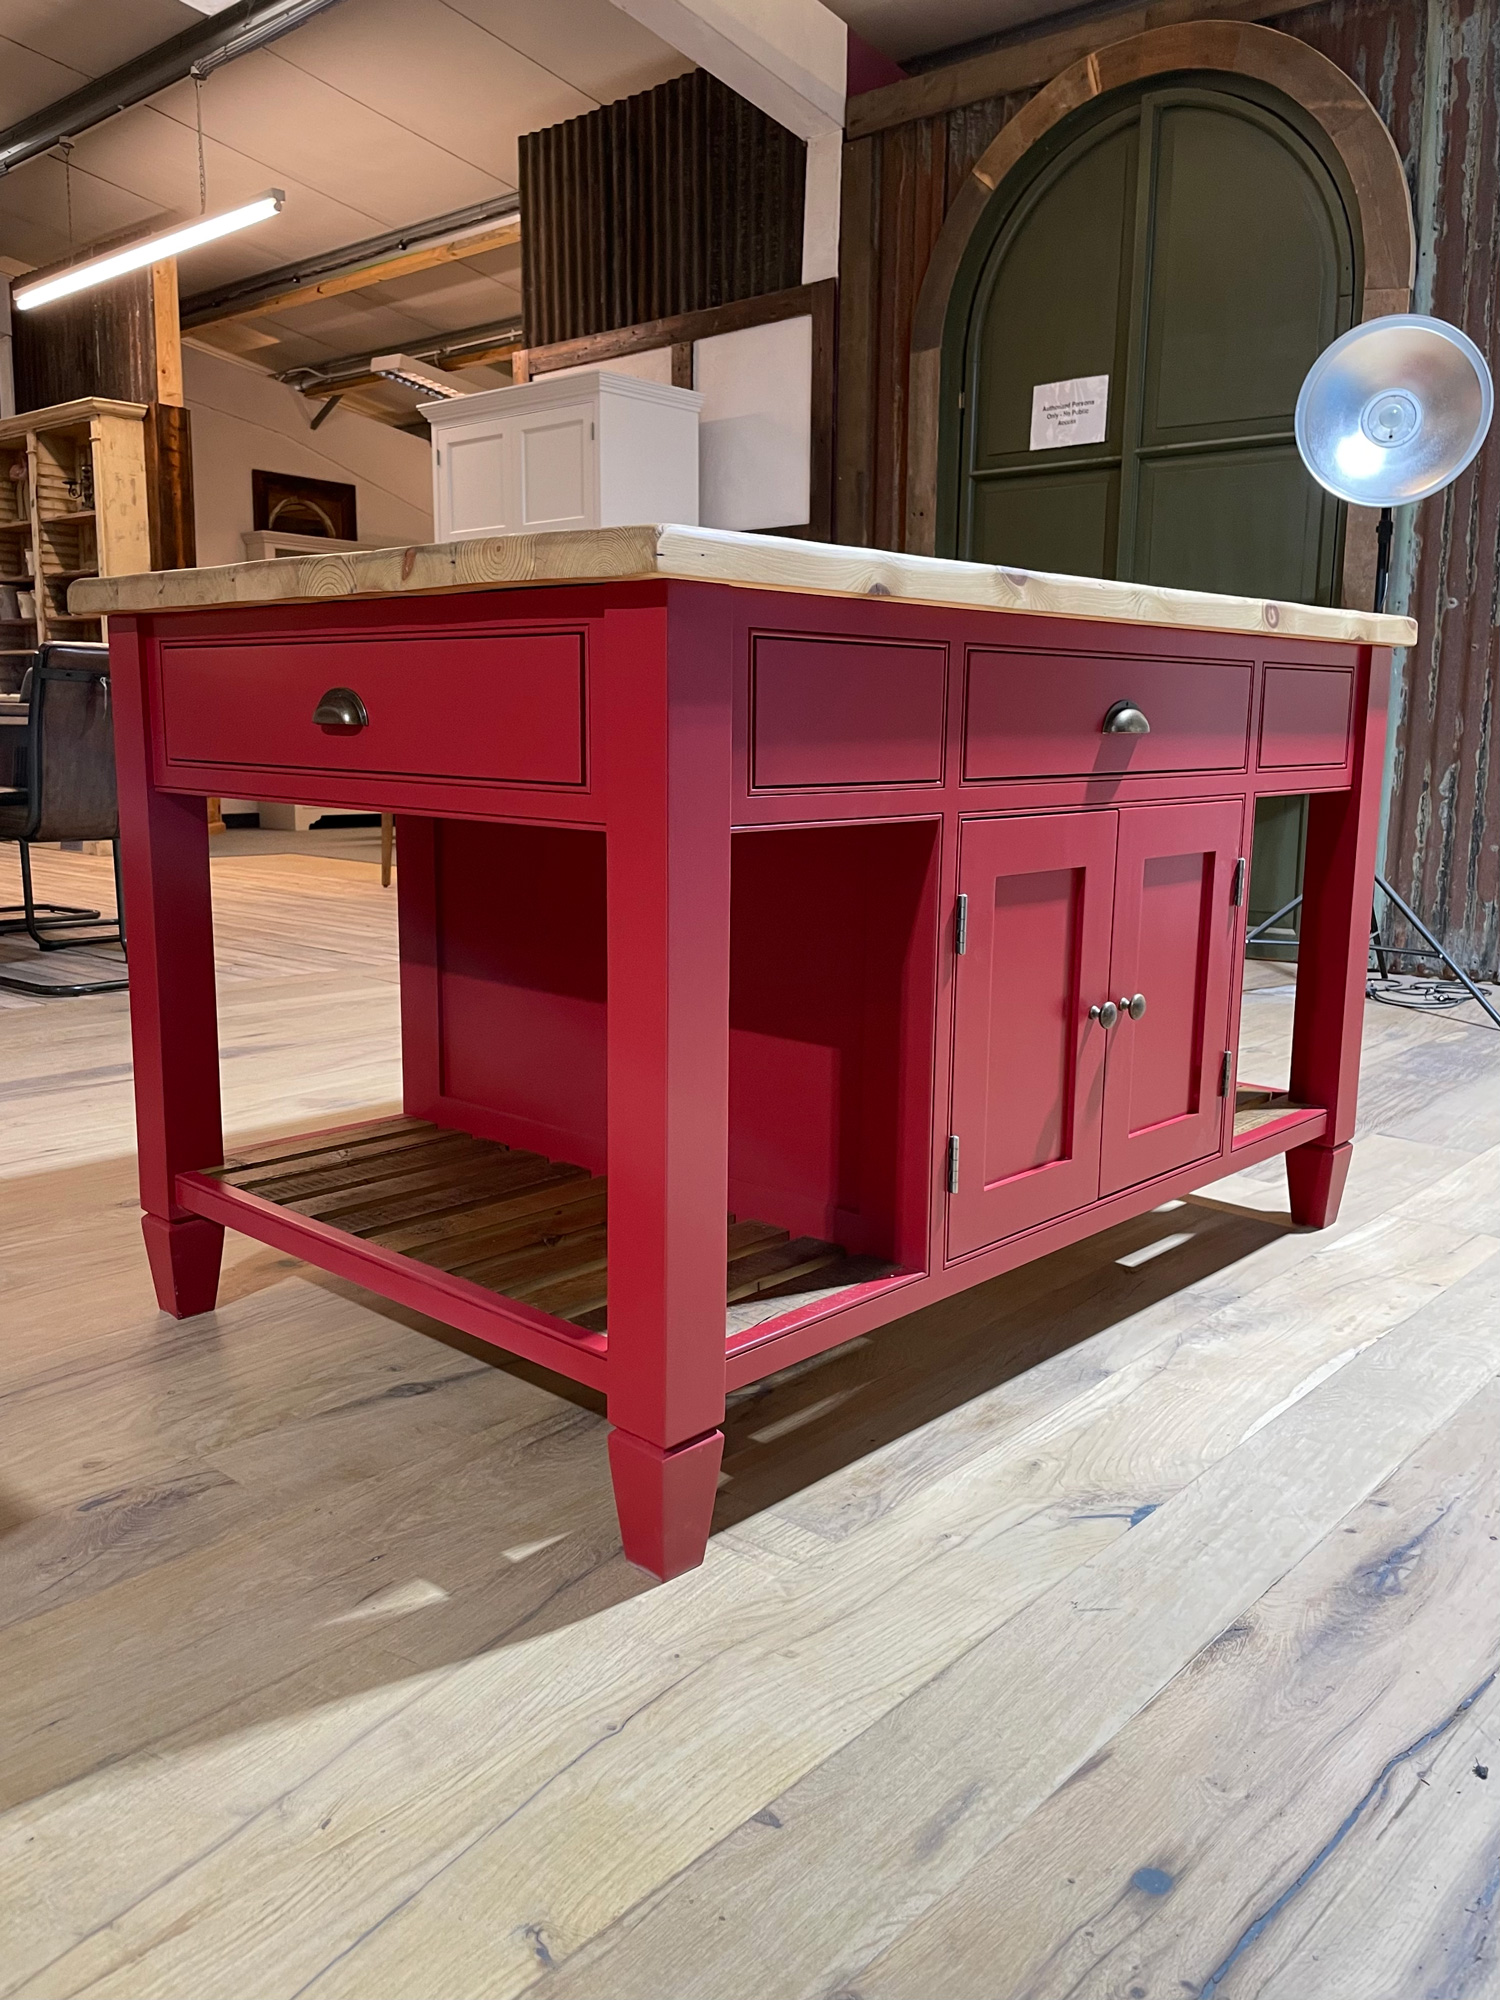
182, 346, 432, 564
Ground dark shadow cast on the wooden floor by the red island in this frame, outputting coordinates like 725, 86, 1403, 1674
0, 1144, 1286, 1804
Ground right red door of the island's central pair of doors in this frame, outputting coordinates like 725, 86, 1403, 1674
1100, 800, 1244, 1194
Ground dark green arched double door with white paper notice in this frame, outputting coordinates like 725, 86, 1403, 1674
938, 76, 1360, 944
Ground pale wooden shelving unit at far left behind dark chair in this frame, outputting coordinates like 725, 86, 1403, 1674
0, 398, 150, 692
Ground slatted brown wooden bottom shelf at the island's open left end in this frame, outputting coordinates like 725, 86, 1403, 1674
210, 1118, 892, 1332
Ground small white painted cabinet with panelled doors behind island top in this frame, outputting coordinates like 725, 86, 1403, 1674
422, 368, 702, 542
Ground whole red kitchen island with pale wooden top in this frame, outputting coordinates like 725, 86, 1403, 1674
72, 528, 1414, 1576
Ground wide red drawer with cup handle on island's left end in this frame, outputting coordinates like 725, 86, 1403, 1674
160, 632, 586, 786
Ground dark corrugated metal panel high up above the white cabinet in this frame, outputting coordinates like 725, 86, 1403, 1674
520, 70, 806, 346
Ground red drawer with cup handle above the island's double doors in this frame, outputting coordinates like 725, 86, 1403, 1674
964, 648, 1254, 784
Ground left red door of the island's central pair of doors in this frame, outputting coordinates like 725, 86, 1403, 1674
948, 810, 1118, 1256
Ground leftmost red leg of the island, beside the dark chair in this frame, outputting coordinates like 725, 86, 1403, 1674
110, 618, 224, 1320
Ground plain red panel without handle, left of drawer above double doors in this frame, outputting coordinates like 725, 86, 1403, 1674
750, 636, 948, 792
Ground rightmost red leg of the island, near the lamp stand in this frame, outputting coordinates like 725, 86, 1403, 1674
1286, 648, 1390, 1230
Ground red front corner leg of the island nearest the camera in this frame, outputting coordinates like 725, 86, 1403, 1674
600, 586, 730, 1576
